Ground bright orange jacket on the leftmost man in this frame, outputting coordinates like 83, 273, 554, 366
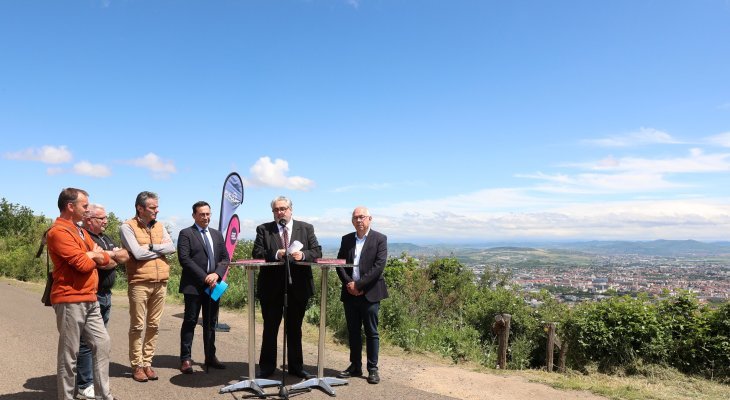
46, 218, 109, 304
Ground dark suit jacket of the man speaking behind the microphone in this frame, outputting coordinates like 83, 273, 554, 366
252, 220, 322, 302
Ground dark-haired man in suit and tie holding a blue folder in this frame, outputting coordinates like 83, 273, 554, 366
177, 201, 230, 374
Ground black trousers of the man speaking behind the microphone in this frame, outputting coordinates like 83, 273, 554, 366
259, 294, 308, 372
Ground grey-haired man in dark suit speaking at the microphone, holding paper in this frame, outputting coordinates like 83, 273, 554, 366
253, 196, 322, 379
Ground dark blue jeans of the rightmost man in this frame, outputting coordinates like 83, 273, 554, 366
343, 296, 380, 371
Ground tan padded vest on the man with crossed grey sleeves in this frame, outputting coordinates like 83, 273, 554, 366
124, 218, 170, 283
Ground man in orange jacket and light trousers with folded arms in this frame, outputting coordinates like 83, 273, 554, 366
46, 188, 114, 400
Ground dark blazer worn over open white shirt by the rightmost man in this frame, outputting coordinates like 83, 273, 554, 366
337, 229, 388, 303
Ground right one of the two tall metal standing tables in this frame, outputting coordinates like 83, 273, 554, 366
291, 259, 354, 396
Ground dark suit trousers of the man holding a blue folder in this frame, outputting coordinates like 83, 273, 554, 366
180, 294, 218, 361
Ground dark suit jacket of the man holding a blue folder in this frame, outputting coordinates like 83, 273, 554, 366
177, 224, 230, 295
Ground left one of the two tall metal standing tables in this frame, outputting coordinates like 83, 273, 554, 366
218, 260, 282, 397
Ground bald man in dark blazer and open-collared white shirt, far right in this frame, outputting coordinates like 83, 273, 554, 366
337, 207, 388, 384
